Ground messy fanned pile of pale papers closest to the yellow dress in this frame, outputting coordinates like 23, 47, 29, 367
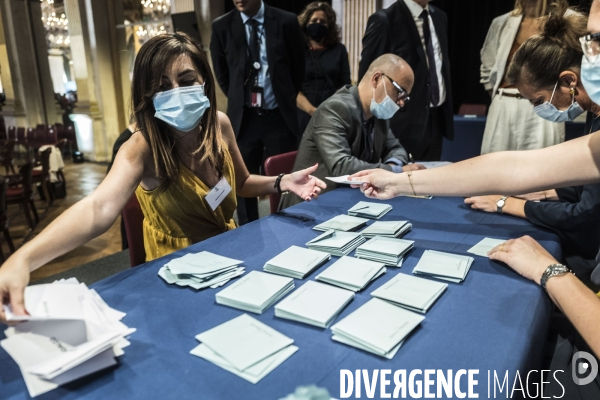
158, 251, 244, 290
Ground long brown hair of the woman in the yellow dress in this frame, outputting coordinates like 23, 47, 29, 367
131, 33, 224, 190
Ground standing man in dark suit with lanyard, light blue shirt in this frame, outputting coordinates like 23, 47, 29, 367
210, 0, 304, 224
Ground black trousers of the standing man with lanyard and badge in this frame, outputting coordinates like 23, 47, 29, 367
237, 107, 297, 225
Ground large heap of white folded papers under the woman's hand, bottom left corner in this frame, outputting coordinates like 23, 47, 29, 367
0, 278, 135, 397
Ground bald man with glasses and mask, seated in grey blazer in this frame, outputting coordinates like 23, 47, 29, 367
281, 54, 425, 208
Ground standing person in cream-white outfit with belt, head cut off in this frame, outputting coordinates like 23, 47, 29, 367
480, 0, 565, 154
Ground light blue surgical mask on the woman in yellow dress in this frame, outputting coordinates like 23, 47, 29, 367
152, 85, 210, 132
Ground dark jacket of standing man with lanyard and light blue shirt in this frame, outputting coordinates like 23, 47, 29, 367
210, 4, 304, 136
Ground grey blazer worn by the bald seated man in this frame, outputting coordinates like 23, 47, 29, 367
281, 85, 407, 208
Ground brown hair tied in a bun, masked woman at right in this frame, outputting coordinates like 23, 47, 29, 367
506, 0, 587, 90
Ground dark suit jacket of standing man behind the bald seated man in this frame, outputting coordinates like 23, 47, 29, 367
358, 0, 454, 145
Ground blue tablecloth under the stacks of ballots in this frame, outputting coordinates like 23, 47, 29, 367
0, 188, 561, 400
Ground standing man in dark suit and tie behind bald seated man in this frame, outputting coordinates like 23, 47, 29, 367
359, 0, 454, 161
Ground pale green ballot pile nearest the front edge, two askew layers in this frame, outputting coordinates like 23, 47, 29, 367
190, 314, 298, 383
